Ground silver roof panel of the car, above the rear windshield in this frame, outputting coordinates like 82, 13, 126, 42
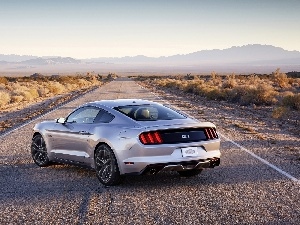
85, 99, 158, 108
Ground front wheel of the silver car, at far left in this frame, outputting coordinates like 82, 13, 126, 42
31, 134, 50, 167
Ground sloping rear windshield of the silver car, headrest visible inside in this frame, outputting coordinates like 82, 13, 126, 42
114, 105, 186, 121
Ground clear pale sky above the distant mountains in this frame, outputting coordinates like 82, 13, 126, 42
0, 0, 300, 59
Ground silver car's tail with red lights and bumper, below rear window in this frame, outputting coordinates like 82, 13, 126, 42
119, 119, 221, 174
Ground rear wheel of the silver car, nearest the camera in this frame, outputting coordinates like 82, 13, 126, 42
95, 144, 121, 186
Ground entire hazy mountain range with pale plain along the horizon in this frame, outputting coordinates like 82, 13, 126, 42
0, 44, 300, 73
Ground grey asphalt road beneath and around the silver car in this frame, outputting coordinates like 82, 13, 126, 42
0, 79, 300, 224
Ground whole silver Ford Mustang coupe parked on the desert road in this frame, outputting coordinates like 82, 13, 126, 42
31, 99, 221, 185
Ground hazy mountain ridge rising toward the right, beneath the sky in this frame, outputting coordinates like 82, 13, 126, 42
84, 44, 300, 64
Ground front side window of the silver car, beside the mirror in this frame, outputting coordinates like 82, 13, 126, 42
67, 107, 100, 123
